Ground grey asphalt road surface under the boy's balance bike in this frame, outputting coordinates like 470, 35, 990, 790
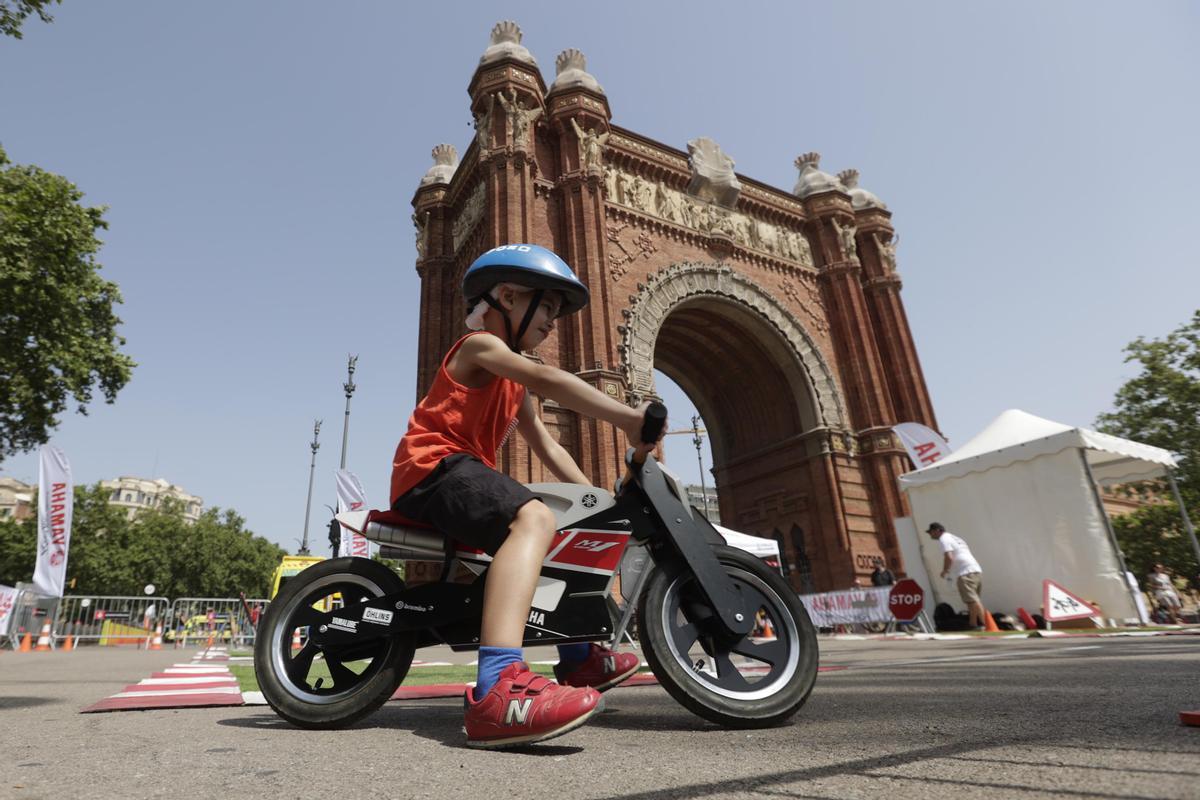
0, 636, 1200, 800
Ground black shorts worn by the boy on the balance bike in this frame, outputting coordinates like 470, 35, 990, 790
391, 453, 538, 555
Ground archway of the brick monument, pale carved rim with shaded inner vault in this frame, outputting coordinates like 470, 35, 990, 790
620, 264, 846, 589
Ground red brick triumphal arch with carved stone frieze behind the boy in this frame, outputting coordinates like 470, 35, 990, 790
413, 23, 936, 590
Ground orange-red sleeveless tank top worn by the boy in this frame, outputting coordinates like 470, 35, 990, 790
389, 331, 526, 505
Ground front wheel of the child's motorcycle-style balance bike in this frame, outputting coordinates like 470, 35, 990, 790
637, 547, 817, 728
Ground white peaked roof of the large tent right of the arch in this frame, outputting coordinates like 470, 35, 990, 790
900, 409, 1176, 489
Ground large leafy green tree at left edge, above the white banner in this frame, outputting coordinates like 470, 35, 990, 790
0, 148, 136, 462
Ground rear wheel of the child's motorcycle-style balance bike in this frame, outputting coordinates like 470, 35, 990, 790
254, 558, 415, 729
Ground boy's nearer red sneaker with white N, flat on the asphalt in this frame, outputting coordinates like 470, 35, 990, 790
463, 661, 604, 747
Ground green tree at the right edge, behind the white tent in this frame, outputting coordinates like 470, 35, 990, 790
1097, 311, 1200, 585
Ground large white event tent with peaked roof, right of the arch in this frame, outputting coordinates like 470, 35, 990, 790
900, 409, 1175, 620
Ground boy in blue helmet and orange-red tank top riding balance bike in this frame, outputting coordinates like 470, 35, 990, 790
391, 245, 655, 747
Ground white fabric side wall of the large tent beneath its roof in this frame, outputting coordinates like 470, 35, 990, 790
906, 447, 1138, 620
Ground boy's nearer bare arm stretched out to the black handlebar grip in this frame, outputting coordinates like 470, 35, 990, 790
458, 328, 655, 451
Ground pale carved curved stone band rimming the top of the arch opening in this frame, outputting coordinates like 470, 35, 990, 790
618, 261, 848, 431
